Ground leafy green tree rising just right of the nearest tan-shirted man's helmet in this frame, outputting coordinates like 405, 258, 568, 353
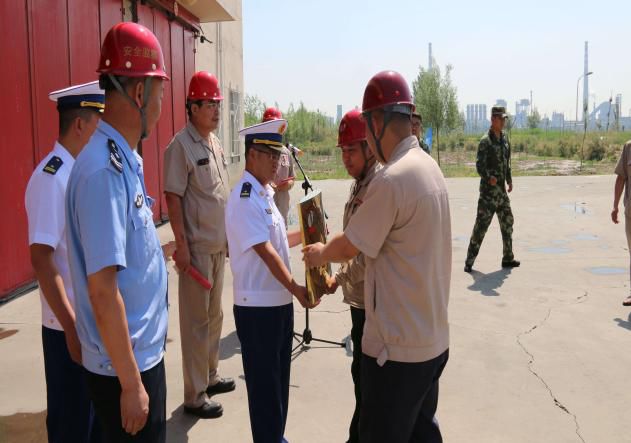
412, 62, 462, 165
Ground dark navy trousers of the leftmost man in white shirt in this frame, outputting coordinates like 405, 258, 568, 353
42, 326, 101, 443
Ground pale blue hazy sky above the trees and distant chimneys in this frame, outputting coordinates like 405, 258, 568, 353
243, 0, 631, 119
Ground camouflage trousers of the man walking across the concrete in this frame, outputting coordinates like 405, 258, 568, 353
465, 192, 515, 266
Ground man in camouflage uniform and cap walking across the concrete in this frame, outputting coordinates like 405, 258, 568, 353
464, 106, 520, 272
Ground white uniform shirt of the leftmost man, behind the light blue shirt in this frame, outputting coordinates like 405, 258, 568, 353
25, 142, 75, 331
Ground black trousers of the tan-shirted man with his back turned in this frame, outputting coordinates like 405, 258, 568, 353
359, 350, 449, 443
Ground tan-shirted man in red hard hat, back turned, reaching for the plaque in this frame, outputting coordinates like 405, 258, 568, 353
304, 71, 451, 443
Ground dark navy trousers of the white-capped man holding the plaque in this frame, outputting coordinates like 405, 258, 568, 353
234, 303, 294, 443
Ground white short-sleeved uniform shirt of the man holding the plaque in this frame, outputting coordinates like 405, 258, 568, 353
226, 171, 292, 307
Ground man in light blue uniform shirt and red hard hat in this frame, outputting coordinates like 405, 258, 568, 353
66, 22, 168, 443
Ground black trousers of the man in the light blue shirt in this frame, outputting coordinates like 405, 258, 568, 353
85, 360, 167, 443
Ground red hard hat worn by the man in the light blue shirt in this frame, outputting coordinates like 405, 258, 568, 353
97, 22, 169, 80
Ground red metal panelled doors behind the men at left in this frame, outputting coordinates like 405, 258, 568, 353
0, 0, 195, 299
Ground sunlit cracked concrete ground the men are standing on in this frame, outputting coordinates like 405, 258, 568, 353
0, 176, 631, 443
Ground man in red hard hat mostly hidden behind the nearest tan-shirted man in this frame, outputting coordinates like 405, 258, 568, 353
327, 109, 379, 443
